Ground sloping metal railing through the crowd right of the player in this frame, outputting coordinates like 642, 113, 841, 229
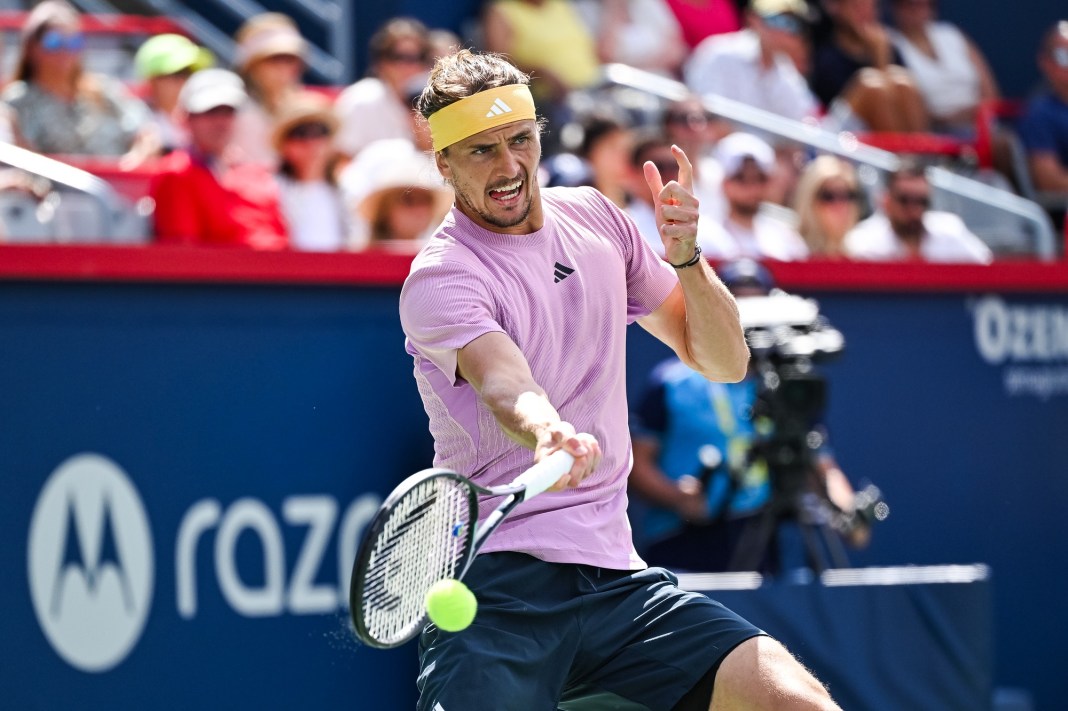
603, 64, 1057, 260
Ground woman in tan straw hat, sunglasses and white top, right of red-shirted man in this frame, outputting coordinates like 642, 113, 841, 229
272, 92, 348, 252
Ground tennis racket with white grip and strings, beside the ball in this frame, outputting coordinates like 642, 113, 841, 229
348, 451, 575, 649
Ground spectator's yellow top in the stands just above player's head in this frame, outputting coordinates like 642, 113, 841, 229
496, 0, 600, 89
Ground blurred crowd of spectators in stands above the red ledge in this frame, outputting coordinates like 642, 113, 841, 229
0, 0, 1068, 264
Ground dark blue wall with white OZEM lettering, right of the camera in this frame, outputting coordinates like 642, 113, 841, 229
628, 291, 1068, 709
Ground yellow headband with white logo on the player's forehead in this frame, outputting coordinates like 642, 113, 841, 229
427, 84, 535, 151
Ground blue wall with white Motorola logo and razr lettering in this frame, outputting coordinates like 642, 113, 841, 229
0, 285, 433, 709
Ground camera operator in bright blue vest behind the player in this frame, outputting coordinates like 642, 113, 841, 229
630, 259, 870, 573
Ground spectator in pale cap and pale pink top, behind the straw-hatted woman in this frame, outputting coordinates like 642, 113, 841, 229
234, 13, 308, 171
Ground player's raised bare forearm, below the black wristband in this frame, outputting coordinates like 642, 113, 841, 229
678, 260, 749, 382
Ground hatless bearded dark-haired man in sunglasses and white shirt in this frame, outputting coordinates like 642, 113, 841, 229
846, 161, 993, 264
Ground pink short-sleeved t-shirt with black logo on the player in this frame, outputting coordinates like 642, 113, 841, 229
401, 188, 678, 570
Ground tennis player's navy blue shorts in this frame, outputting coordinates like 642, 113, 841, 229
418, 553, 764, 711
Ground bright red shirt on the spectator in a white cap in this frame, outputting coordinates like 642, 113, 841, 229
152, 151, 289, 250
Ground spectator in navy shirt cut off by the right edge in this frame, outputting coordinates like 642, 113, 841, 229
1018, 20, 1068, 194
